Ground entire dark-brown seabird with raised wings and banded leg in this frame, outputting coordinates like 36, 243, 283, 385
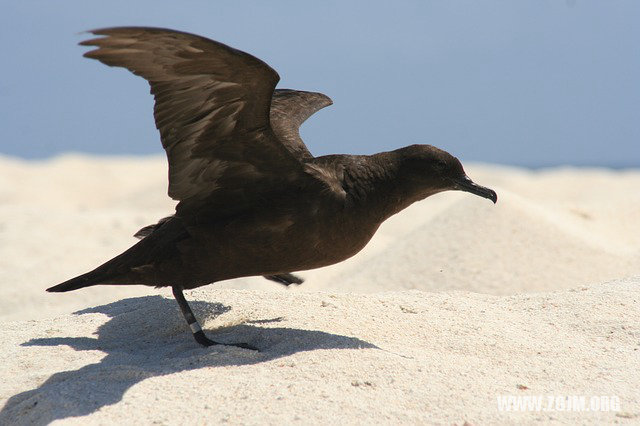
47, 27, 497, 350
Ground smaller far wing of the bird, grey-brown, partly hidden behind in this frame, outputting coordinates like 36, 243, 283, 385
271, 89, 333, 161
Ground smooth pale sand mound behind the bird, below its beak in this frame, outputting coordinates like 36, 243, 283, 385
320, 190, 640, 294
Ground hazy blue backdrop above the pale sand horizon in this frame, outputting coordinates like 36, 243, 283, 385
0, 0, 640, 167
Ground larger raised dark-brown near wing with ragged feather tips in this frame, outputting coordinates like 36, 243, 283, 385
80, 27, 340, 214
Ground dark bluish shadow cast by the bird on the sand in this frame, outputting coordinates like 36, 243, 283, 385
0, 296, 377, 424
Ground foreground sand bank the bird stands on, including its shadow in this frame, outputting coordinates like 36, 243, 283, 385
0, 278, 640, 424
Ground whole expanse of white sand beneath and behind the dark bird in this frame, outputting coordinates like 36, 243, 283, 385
0, 156, 640, 424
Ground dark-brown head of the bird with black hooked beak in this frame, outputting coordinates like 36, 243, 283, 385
395, 145, 498, 203
